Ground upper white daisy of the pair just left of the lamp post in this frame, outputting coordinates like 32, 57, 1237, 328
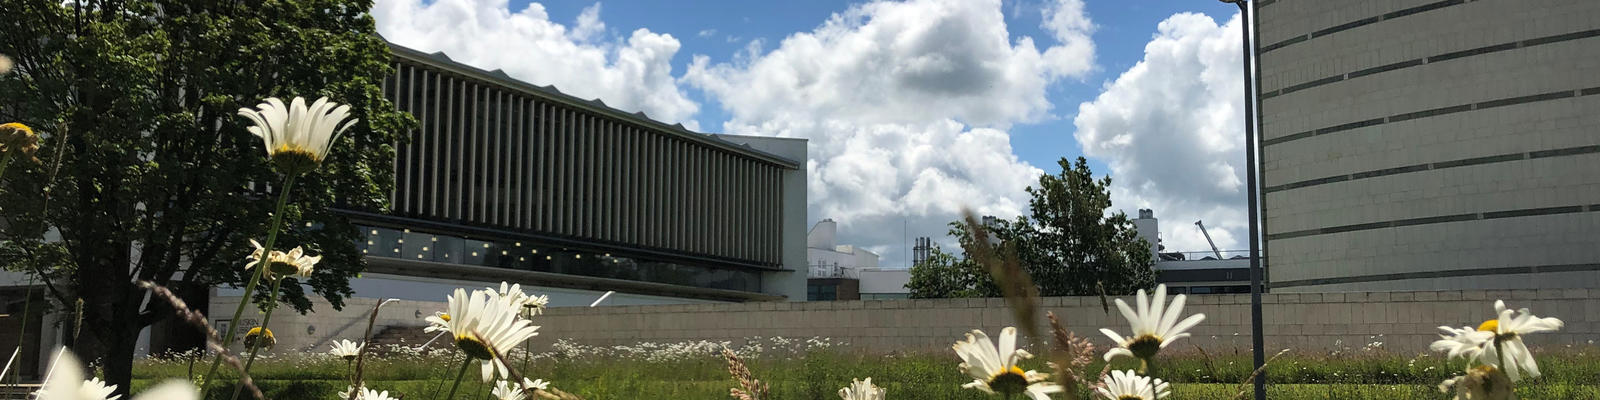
1101, 285, 1205, 362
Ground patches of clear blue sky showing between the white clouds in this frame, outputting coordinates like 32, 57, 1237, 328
524, 0, 1237, 173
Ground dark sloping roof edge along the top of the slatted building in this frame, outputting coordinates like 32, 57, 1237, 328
386, 40, 803, 170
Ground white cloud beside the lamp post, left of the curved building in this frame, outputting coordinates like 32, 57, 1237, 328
1074, 13, 1248, 251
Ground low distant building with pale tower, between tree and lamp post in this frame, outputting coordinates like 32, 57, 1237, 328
1133, 208, 1250, 294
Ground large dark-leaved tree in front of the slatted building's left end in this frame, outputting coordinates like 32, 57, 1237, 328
0, 0, 414, 394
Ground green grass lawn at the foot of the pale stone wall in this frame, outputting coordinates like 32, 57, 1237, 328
134, 349, 1600, 400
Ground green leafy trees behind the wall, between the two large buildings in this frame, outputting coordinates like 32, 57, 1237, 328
906, 157, 1155, 298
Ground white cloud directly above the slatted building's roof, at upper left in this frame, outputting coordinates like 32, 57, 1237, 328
371, 0, 699, 128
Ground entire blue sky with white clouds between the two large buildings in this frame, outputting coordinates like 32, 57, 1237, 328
373, 0, 1245, 266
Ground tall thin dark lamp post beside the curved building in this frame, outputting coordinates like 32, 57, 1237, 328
1221, 0, 1267, 400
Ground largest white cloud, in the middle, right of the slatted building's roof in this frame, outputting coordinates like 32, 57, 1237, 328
683, 0, 1094, 266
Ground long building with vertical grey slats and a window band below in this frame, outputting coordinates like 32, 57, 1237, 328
0, 40, 806, 368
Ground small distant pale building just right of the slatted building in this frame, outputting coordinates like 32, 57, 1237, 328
805, 219, 878, 301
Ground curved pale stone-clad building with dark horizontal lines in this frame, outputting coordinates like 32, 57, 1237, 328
1256, 0, 1600, 293
